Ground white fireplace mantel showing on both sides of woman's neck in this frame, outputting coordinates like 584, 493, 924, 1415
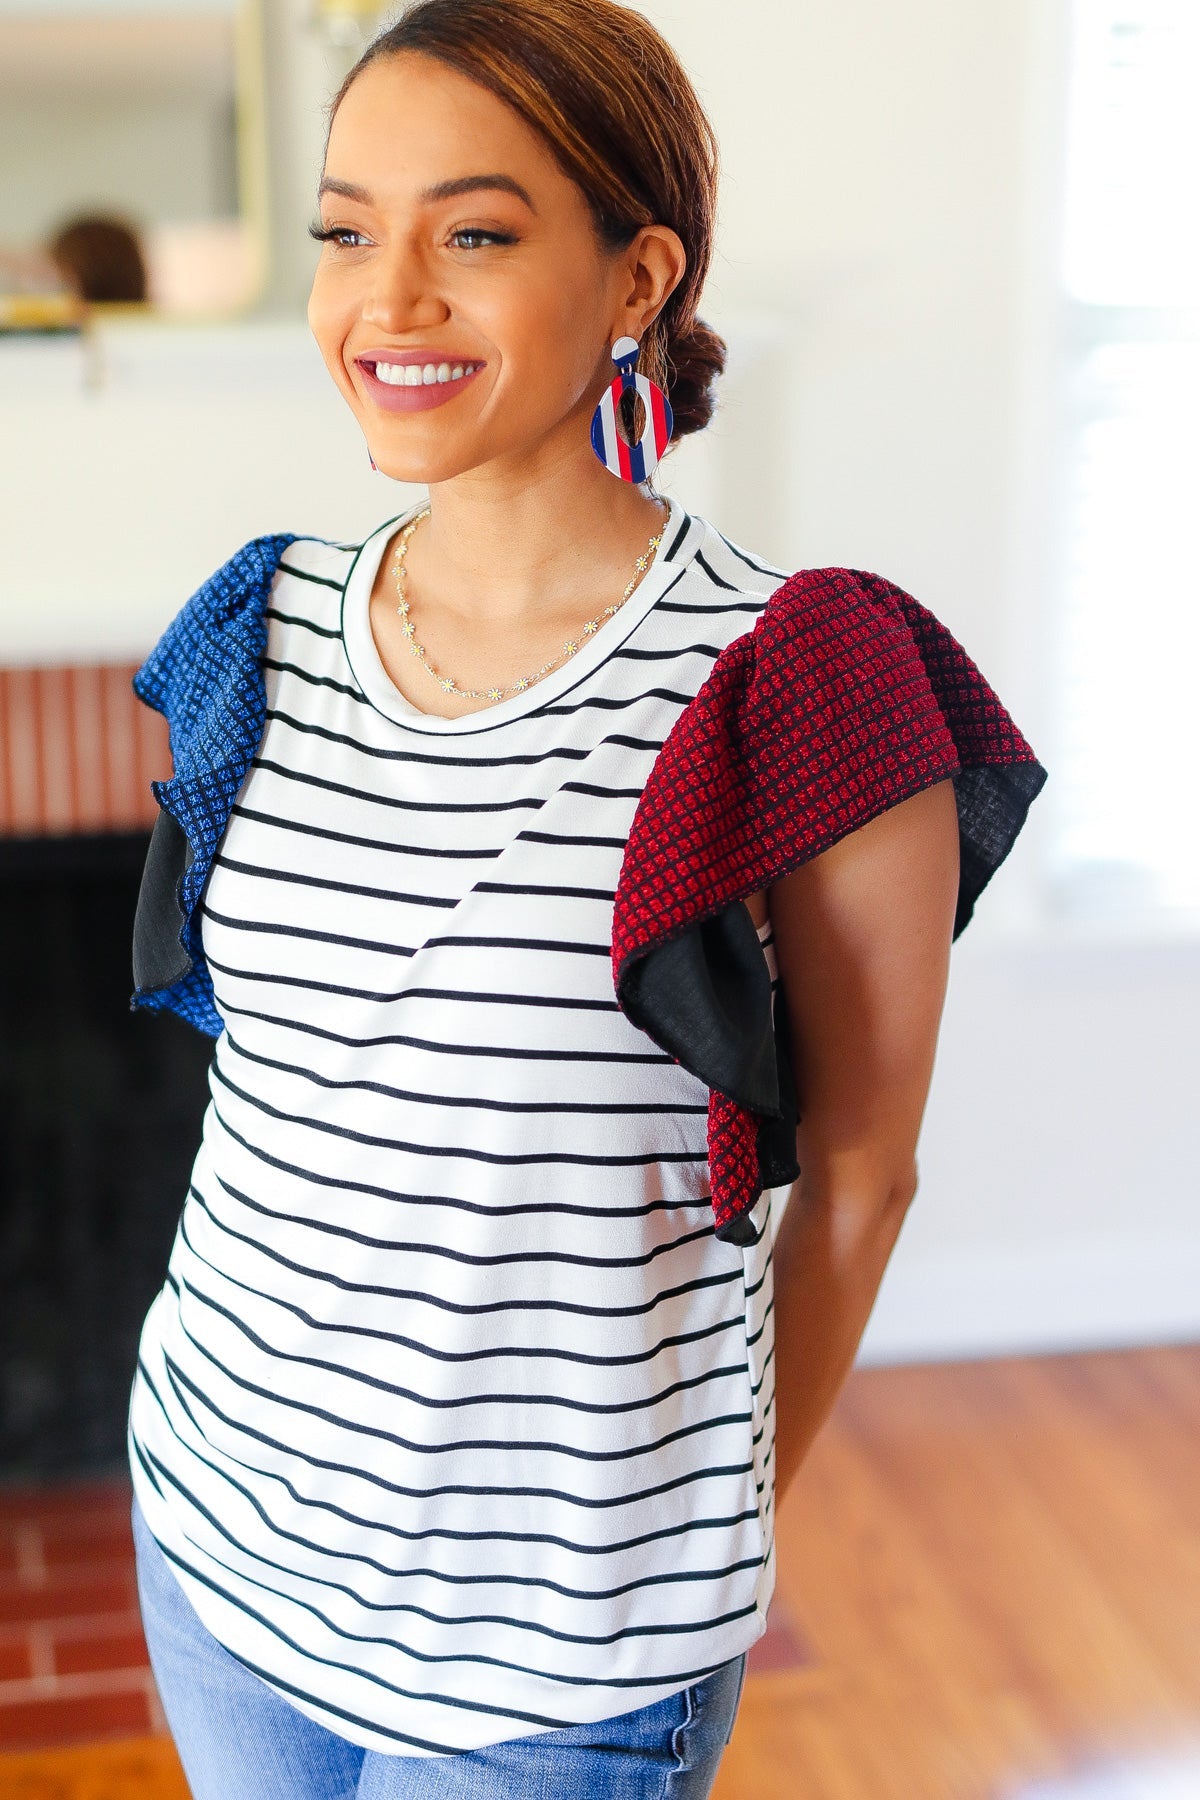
0, 317, 788, 664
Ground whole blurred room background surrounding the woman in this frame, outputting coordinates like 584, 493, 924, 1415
0, 0, 1200, 1800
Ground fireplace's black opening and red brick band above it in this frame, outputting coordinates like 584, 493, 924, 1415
0, 662, 212, 1483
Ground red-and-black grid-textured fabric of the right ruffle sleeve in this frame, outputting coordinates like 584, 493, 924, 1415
612, 569, 1047, 1242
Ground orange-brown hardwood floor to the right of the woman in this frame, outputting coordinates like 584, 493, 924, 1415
712, 1345, 1200, 1800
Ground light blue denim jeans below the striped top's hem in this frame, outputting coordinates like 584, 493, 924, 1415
133, 1499, 747, 1800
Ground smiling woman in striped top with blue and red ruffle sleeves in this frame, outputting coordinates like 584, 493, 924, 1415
130, 0, 1042, 1800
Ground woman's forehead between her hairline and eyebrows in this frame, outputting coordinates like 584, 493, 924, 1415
326, 50, 574, 197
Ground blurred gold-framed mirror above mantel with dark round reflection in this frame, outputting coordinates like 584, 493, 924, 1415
0, 0, 266, 318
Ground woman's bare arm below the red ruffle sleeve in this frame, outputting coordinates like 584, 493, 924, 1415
768, 778, 959, 1505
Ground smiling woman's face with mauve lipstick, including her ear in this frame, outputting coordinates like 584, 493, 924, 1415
308, 52, 684, 482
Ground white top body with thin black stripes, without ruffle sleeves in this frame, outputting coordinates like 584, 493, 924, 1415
130, 500, 798, 1757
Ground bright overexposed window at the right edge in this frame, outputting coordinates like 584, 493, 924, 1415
1047, 0, 1200, 929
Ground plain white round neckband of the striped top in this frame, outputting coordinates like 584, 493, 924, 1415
342, 493, 703, 736
